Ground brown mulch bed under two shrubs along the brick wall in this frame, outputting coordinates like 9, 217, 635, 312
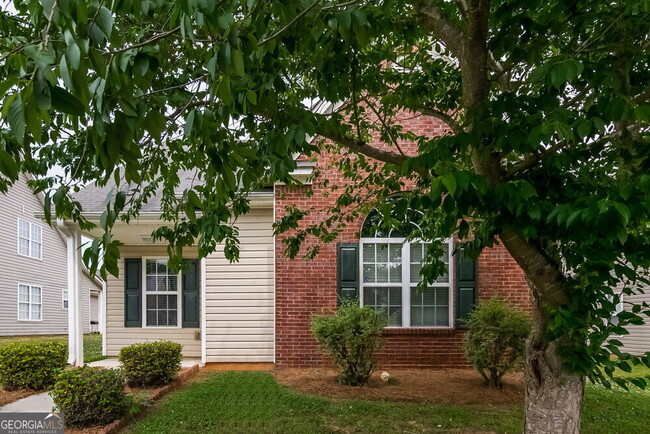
275, 368, 524, 406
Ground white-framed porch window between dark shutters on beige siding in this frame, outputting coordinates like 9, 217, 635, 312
142, 258, 181, 327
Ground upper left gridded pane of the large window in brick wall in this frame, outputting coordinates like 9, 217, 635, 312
363, 243, 402, 283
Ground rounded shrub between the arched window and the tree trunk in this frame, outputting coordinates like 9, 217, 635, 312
464, 298, 531, 389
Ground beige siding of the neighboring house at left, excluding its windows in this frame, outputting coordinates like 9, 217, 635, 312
0, 176, 98, 336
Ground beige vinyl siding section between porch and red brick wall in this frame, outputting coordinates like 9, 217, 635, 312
205, 208, 275, 362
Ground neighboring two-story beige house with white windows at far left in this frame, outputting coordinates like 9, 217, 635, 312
0, 175, 102, 336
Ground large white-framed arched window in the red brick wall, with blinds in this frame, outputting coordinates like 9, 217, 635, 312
360, 210, 453, 327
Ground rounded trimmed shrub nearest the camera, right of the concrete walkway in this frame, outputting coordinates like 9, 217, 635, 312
50, 366, 131, 427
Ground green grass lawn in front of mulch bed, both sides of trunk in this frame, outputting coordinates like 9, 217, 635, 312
128, 372, 650, 434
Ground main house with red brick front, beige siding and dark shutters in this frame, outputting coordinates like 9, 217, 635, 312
63, 113, 647, 367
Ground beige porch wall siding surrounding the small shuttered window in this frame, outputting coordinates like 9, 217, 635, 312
106, 244, 201, 358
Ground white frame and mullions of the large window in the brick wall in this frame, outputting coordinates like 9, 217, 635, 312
359, 236, 456, 329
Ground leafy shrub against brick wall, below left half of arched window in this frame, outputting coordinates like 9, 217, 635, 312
311, 302, 388, 386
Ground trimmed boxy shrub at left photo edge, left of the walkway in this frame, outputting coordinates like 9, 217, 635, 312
0, 342, 68, 390
